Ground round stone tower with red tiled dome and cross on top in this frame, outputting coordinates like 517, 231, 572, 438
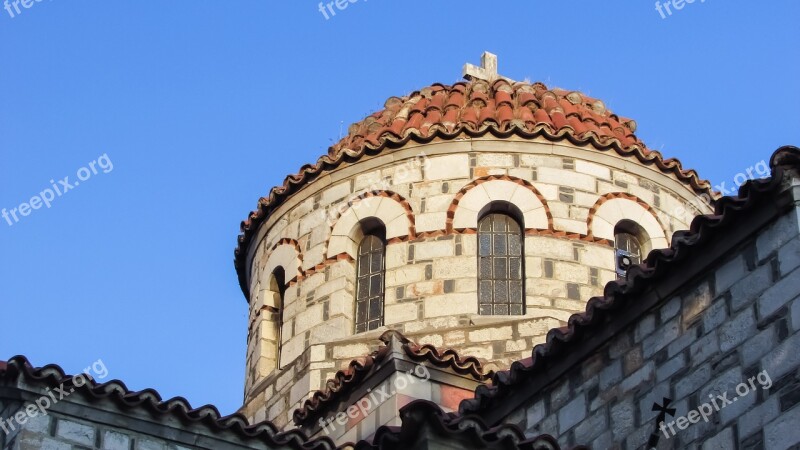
235, 53, 712, 432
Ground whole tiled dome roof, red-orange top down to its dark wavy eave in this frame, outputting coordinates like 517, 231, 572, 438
234, 79, 714, 295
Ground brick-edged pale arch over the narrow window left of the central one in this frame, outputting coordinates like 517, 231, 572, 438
325, 191, 416, 260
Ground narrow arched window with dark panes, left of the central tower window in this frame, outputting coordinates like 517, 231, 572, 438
356, 221, 386, 333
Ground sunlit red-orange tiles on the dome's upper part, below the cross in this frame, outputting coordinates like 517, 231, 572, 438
340, 79, 644, 154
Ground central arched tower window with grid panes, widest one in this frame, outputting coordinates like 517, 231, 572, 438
478, 205, 525, 315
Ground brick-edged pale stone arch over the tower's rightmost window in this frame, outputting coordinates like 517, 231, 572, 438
586, 192, 669, 249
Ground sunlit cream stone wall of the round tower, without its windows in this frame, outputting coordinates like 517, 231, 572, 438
243, 138, 707, 425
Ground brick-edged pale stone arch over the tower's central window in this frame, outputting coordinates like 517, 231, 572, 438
445, 175, 553, 233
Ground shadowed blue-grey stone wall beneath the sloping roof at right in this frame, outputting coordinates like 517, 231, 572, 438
507, 206, 800, 450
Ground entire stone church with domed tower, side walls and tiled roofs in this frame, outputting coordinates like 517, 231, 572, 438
0, 54, 800, 449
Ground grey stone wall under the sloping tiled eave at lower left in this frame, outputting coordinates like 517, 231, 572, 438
0, 380, 308, 450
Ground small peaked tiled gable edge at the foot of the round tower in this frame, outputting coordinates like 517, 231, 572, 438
292, 330, 494, 425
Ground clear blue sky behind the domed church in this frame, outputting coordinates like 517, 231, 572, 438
0, 0, 800, 413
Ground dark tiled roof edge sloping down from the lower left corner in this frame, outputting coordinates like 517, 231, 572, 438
0, 355, 336, 450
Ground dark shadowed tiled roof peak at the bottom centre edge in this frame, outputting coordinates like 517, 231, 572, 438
355, 400, 586, 450
